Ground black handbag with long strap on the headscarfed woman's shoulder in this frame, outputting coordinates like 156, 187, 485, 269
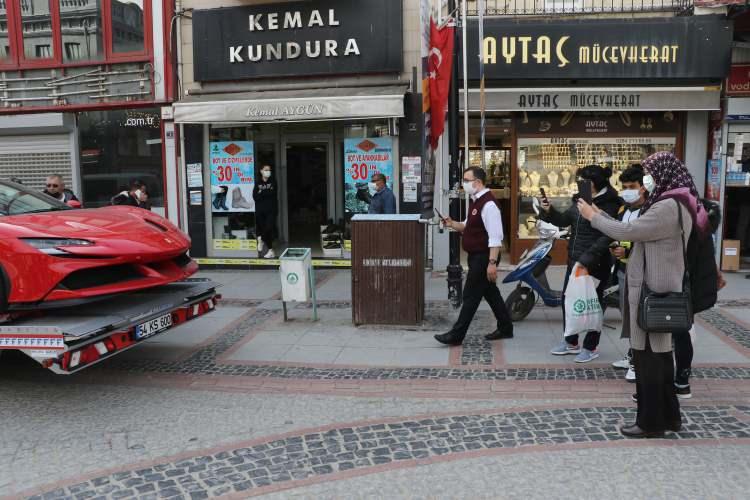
638, 200, 693, 333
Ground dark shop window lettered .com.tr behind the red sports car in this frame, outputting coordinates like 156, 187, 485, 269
78, 108, 164, 212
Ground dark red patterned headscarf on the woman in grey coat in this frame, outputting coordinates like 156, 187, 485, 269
641, 151, 708, 232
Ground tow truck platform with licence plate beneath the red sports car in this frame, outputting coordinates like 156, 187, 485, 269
0, 278, 221, 375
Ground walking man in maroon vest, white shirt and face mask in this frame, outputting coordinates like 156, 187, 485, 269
435, 167, 513, 345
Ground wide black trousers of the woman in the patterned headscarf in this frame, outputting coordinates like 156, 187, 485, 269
633, 340, 680, 432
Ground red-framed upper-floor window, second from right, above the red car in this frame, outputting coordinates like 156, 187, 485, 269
58, 0, 104, 62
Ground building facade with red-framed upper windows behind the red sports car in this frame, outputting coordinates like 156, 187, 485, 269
0, 0, 177, 220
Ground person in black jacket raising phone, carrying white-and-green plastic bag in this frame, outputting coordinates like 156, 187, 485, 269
540, 165, 622, 363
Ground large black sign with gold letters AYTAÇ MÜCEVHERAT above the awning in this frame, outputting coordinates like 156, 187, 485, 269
467, 16, 732, 80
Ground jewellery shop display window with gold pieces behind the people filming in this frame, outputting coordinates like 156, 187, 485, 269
518, 137, 676, 239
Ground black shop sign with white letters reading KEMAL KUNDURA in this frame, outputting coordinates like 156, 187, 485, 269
192, 0, 403, 81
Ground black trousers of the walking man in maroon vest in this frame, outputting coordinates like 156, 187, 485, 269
453, 251, 513, 337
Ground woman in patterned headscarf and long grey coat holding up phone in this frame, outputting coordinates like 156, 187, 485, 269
578, 152, 709, 437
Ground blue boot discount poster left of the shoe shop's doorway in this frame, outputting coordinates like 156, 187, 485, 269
209, 141, 255, 212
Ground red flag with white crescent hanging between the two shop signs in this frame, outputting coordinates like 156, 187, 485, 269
427, 19, 454, 149
